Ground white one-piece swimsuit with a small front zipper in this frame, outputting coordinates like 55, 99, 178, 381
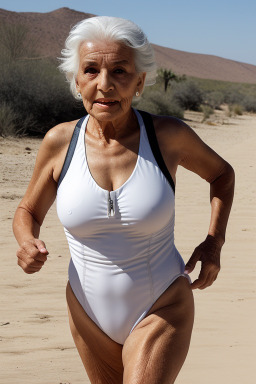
57, 110, 187, 344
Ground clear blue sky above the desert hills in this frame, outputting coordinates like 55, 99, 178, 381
0, 0, 256, 65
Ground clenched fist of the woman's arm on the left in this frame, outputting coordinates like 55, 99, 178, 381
17, 239, 49, 274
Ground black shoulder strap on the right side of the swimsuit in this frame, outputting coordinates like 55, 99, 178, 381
138, 111, 175, 193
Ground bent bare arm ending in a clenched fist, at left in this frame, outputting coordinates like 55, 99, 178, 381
13, 125, 68, 273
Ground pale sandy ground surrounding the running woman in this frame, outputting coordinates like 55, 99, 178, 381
0, 112, 256, 384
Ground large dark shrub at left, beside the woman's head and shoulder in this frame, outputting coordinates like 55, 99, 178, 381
0, 59, 85, 135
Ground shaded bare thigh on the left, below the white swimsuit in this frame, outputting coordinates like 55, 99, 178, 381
67, 283, 123, 384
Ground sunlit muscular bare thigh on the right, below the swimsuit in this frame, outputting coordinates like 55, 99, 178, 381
123, 277, 194, 384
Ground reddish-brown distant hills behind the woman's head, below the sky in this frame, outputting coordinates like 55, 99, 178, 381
0, 8, 256, 84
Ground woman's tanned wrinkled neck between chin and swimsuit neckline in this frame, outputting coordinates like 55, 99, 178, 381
87, 109, 138, 144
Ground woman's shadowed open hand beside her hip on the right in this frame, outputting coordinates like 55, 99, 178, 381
185, 235, 222, 289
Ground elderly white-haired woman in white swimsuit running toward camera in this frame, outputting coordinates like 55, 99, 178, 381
13, 17, 234, 384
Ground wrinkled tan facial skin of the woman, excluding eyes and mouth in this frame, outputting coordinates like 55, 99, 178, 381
76, 41, 145, 135
